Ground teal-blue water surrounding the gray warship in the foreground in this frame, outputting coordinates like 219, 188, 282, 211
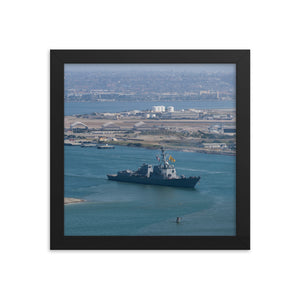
65, 146, 236, 236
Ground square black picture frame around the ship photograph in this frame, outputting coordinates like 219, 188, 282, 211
50, 50, 250, 250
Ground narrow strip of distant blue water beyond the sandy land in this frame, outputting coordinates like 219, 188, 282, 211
65, 100, 236, 116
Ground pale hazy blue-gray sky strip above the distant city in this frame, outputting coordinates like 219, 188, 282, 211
65, 64, 235, 73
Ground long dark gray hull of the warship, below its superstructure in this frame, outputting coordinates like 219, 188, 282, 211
107, 175, 200, 188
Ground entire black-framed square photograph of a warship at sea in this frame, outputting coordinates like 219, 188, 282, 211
50, 50, 250, 250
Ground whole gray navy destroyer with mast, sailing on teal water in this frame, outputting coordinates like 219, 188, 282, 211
107, 147, 200, 188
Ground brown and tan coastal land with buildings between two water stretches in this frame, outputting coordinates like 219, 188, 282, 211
64, 109, 236, 155
